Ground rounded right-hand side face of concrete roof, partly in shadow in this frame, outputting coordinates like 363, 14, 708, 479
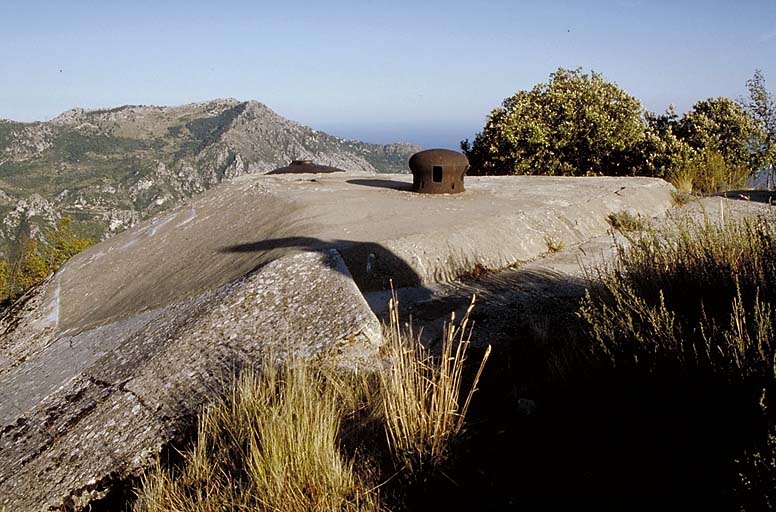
341, 179, 675, 292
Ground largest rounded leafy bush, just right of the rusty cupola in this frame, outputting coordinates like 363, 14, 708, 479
462, 68, 645, 175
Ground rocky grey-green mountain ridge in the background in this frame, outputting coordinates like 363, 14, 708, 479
0, 98, 420, 258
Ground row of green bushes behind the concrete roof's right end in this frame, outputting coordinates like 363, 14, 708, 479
461, 68, 770, 192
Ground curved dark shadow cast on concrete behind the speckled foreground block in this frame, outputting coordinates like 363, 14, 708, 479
220, 236, 420, 291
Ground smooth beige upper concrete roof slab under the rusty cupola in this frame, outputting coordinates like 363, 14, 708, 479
30, 175, 672, 332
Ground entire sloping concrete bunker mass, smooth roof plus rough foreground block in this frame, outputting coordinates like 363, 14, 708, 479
0, 171, 673, 510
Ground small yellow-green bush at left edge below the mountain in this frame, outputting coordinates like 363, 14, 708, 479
0, 217, 94, 301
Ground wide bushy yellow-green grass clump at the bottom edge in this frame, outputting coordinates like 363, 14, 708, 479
135, 359, 377, 512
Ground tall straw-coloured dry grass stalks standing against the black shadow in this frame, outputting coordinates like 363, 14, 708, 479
381, 296, 490, 471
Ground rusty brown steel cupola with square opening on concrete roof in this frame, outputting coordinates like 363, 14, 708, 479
410, 149, 469, 194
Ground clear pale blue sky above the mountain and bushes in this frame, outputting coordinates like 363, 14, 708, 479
0, 0, 776, 148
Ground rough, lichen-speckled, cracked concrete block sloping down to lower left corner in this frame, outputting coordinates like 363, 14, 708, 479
0, 250, 382, 511
